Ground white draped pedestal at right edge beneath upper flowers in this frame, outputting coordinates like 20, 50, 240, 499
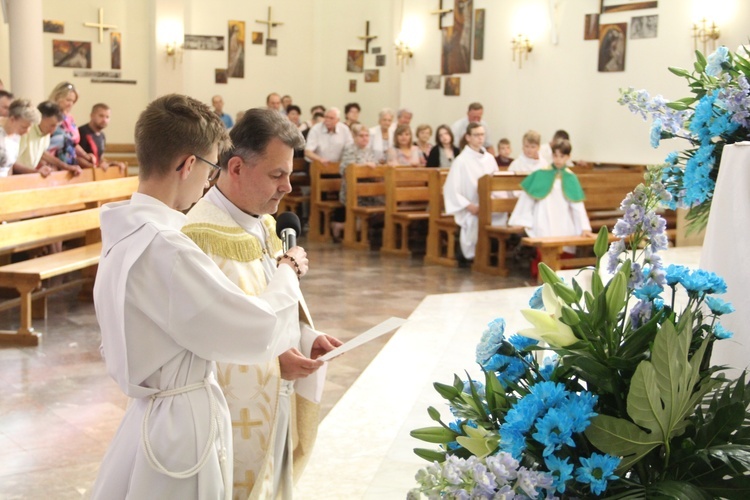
701, 141, 750, 377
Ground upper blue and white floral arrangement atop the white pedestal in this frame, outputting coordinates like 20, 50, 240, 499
618, 46, 750, 230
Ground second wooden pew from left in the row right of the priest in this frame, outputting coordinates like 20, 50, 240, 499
344, 165, 384, 250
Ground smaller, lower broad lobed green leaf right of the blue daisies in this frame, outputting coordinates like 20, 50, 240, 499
585, 415, 662, 471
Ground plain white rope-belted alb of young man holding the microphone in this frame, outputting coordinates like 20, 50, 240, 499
92, 193, 302, 500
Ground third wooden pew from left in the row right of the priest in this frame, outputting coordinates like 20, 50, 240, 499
380, 167, 431, 257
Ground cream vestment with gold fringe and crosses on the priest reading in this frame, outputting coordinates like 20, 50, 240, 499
182, 186, 326, 499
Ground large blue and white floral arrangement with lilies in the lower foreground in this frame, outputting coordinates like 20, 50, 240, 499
409, 166, 750, 499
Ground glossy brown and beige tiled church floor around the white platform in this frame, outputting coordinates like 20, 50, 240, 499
0, 241, 528, 499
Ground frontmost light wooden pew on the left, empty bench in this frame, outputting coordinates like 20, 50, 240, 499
0, 177, 138, 346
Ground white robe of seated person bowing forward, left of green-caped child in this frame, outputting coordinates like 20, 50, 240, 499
443, 146, 508, 259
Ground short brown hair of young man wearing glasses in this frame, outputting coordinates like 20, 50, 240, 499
135, 94, 231, 180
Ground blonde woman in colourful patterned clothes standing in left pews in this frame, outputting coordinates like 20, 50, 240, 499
42, 82, 96, 175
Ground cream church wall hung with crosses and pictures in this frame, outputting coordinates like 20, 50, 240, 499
0, 0, 750, 156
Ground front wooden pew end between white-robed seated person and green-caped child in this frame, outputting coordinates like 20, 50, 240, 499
471, 172, 527, 276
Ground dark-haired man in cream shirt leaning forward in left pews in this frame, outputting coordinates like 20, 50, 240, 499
13, 101, 63, 177
